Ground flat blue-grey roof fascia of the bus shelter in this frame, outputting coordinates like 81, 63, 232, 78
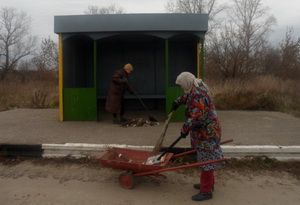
54, 13, 208, 33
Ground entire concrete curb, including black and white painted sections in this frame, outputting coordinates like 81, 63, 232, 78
0, 143, 300, 161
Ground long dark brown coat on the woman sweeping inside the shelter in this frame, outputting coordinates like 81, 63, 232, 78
105, 69, 132, 114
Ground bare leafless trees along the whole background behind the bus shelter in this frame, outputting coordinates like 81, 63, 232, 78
0, 0, 300, 79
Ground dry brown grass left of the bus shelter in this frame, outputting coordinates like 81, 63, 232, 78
0, 71, 58, 111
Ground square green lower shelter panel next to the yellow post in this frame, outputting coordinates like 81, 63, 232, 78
63, 88, 97, 121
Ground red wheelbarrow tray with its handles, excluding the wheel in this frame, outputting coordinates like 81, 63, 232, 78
99, 148, 225, 176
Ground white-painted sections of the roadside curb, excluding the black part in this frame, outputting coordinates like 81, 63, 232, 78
42, 143, 300, 160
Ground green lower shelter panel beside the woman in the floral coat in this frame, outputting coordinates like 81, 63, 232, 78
166, 87, 185, 121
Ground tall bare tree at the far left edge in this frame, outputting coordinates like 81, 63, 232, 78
0, 7, 36, 79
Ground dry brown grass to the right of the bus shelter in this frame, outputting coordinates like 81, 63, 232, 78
209, 75, 300, 116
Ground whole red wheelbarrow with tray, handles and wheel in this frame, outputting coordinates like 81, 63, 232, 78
99, 141, 229, 189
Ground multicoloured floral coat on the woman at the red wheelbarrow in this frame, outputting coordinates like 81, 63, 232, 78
175, 84, 223, 171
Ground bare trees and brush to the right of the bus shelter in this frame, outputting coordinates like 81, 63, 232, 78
167, 0, 300, 79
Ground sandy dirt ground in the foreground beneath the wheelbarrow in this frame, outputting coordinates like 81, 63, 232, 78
0, 160, 300, 205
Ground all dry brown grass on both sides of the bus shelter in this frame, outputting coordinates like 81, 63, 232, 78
0, 71, 300, 117
